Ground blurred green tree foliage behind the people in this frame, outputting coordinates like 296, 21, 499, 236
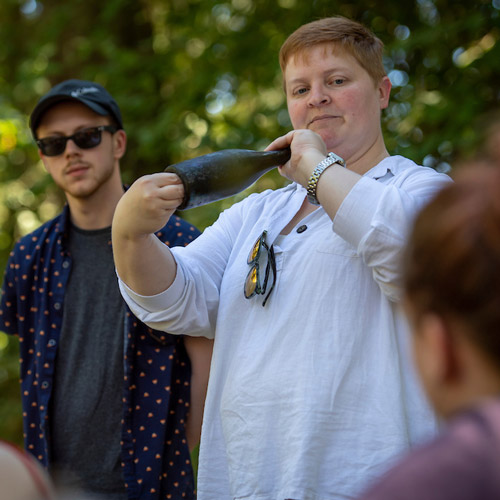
0, 0, 500, 443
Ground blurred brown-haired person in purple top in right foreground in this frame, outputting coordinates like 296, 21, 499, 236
362, 165, 500, 500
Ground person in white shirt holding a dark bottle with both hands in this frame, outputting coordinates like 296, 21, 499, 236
113, 17, 450, 500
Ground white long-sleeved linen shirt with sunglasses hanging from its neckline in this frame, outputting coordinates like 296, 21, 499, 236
120, 156, 450, 500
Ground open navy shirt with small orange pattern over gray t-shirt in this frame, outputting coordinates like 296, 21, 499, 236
0, 206, 199, 500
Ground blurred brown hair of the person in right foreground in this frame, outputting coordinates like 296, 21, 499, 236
404, 164, 500, 367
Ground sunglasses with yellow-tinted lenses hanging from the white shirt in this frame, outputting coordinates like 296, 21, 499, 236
244, 231, 276, 306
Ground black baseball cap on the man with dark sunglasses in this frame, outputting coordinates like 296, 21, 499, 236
30, 80, 123, 138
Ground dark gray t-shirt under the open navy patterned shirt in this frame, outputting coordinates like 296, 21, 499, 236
50, 226, 127, 499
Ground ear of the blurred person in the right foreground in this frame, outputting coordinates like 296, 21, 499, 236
417, 313, 460, 384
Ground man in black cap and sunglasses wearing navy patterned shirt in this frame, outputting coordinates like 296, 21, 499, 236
0, 80, 211, 499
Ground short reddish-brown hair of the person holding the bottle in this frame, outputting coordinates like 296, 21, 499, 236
279, 16, 386, 85
